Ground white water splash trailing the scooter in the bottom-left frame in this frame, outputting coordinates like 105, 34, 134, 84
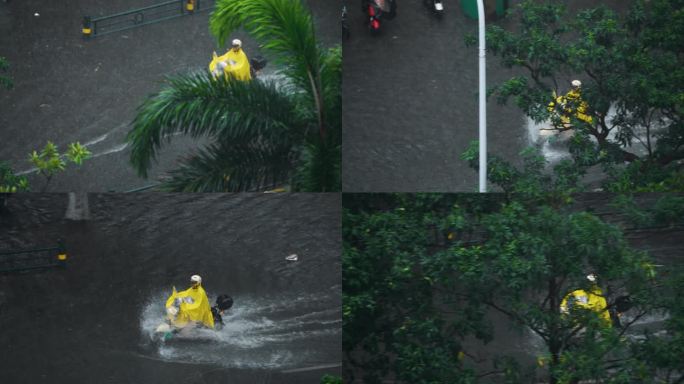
140, 293, 342, 369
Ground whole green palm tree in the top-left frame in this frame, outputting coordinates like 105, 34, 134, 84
127, 0, 342, 192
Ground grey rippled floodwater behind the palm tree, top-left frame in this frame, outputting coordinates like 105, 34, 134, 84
0, 0, 340, 192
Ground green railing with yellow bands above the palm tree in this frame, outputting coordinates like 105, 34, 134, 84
83, 0, 215, 37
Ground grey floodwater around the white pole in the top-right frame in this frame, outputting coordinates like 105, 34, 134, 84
342, 0, 625, 192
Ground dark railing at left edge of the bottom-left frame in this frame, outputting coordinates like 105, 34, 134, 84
0, 240, 68, 273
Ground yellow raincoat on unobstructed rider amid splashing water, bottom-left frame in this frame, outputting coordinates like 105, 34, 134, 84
166, 285, 214, 328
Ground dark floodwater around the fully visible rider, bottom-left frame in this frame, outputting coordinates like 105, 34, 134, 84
0, 194, 342, 383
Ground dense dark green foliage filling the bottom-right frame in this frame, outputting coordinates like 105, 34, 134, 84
343, 194, 684, 383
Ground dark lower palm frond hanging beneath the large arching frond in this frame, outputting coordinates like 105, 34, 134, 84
162, 142, 295, 192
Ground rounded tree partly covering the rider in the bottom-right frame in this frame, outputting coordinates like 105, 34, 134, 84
426, 202, 654, 383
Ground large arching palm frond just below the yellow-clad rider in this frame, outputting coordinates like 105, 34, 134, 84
127, 73, 303, 177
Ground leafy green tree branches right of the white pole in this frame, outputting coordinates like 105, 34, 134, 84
480, 0, 684, 191
